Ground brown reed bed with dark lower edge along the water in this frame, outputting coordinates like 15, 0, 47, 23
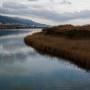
25, 24, 90, 69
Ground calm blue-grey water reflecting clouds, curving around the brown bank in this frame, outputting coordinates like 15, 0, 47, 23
0, 30, 90, 90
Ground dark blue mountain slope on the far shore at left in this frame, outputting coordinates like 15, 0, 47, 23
0, 15, 48, 27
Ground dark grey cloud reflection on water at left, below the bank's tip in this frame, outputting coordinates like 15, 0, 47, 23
0, 48, 36, 64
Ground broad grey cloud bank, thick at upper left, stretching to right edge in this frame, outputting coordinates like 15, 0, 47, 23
0, 2, 90, 22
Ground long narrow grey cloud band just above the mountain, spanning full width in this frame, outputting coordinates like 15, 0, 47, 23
0, 5, 90, 22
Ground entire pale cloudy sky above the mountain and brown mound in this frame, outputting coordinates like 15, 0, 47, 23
0, 0, 90, 25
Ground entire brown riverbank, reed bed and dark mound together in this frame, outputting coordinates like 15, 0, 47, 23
25, 25, 90, 70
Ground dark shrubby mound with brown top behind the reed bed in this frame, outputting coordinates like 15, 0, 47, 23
43, 25, 90, 39
